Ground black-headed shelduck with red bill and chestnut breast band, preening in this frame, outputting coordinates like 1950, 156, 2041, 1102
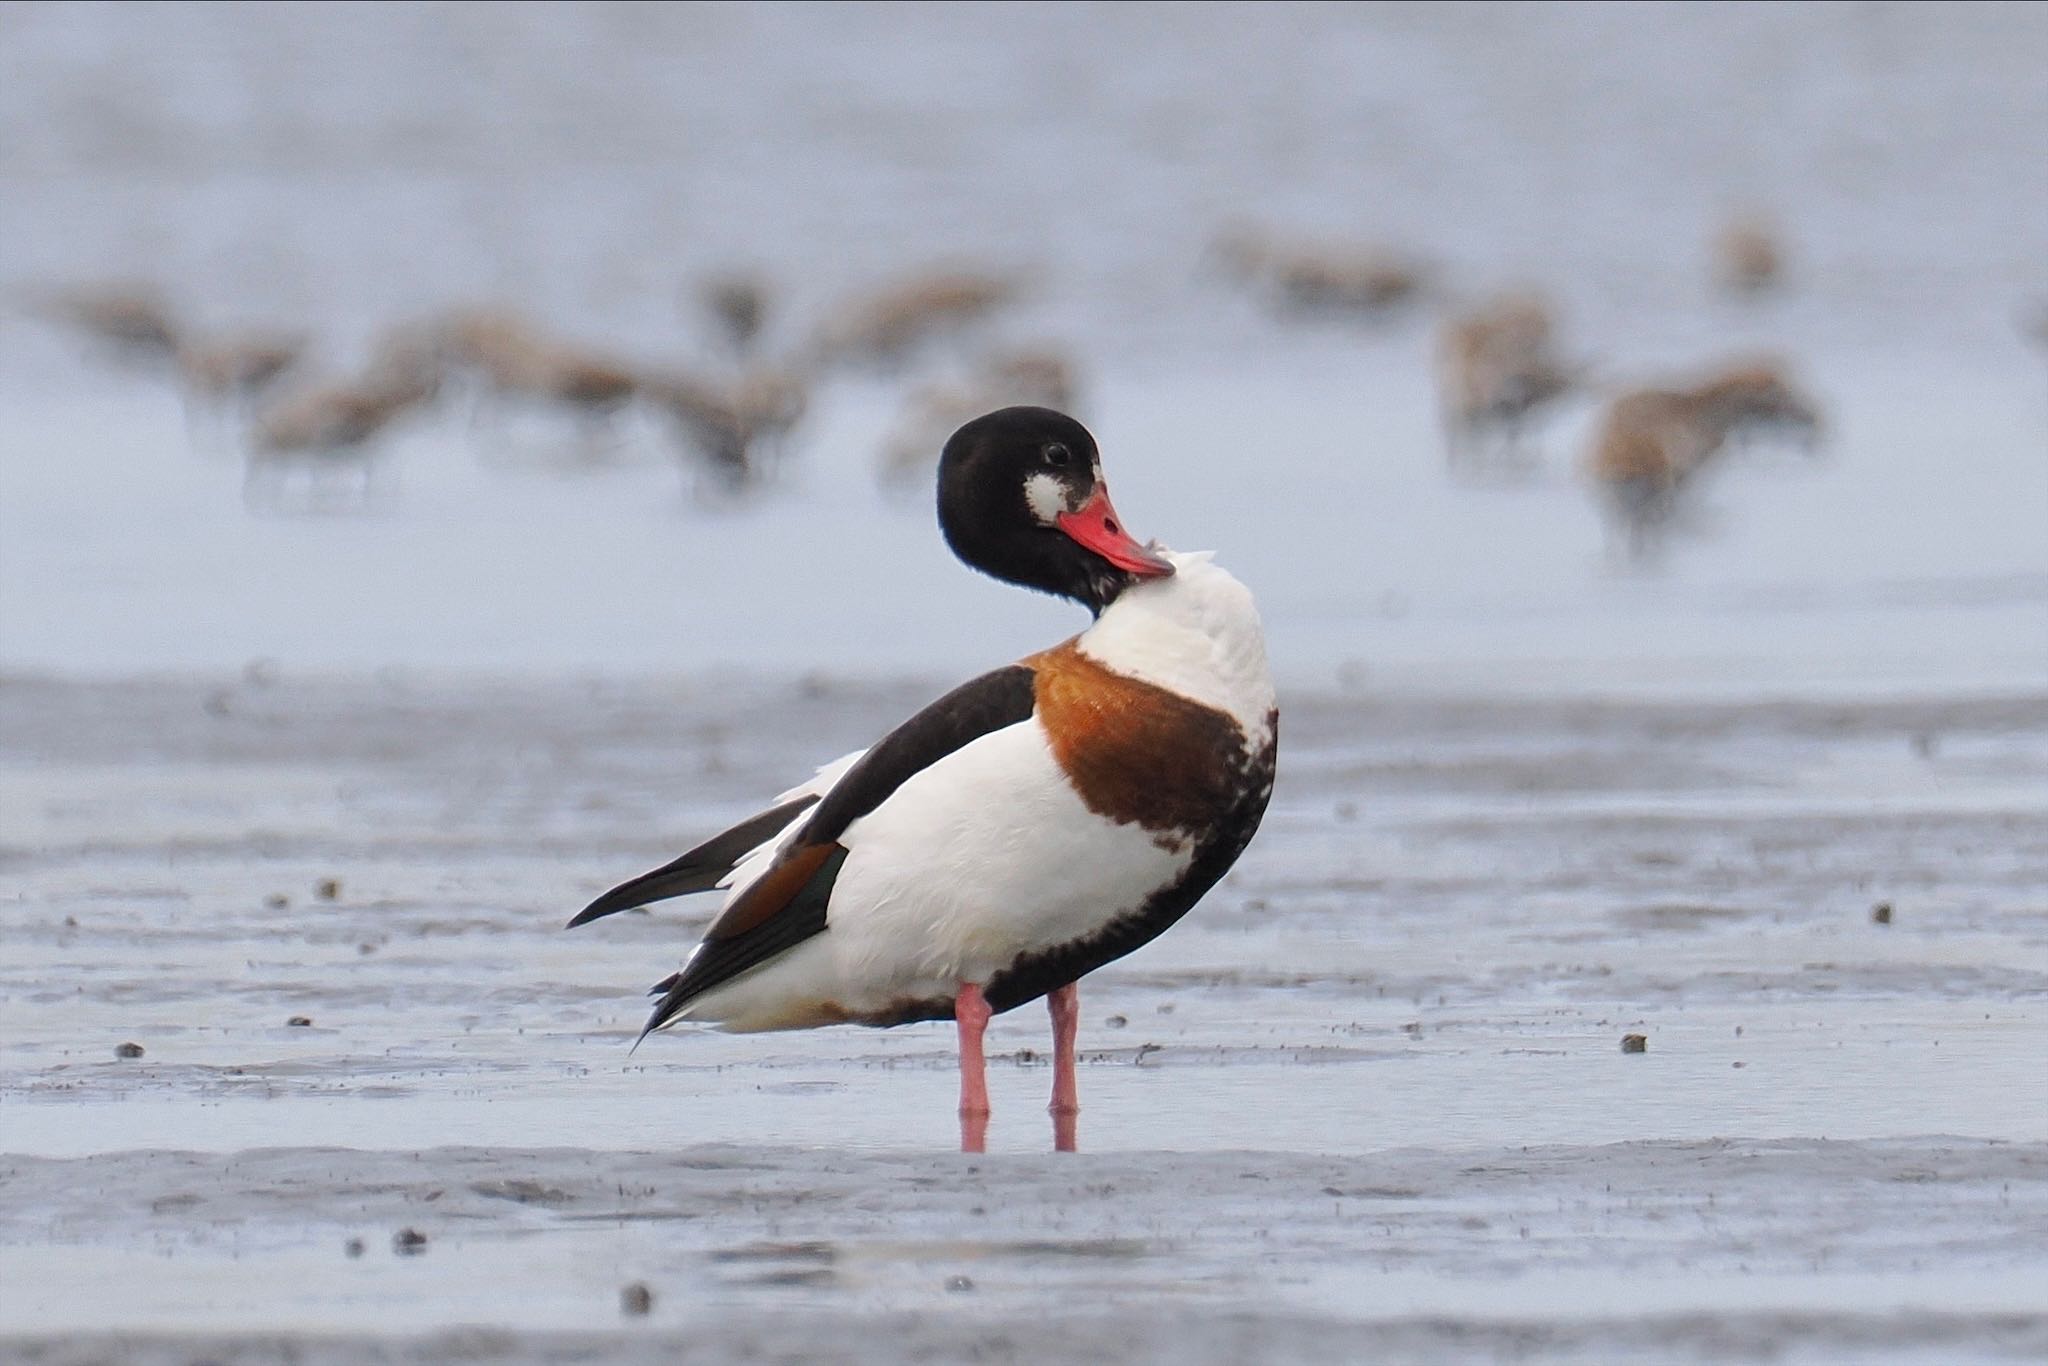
569, 408, 1280, 1153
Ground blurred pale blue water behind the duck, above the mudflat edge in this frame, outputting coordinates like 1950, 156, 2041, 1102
0, 4, 2048, 690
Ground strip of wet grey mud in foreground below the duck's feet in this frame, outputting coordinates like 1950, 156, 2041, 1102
0, 1139, 2048, 1362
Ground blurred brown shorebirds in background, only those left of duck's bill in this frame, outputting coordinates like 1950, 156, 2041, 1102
19, 270, 1077, 506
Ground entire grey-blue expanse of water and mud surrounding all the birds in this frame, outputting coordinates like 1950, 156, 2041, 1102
0, 4, 2048, 1366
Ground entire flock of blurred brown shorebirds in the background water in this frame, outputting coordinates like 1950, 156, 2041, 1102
19, 217, 2048, 559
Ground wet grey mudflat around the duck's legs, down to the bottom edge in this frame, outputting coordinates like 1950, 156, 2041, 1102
0, 670, 2048, 1362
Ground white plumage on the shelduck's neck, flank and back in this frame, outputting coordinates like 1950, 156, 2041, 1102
678, 553, 1274, 1030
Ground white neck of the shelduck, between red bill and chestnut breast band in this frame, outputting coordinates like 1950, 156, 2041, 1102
1075, 551, 1274, 745
